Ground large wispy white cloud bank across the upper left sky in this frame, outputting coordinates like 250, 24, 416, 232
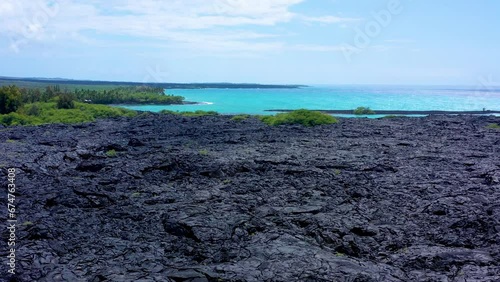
0, 0, 356, 51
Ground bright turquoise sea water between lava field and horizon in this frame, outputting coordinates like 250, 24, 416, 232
123, 86, 500, 114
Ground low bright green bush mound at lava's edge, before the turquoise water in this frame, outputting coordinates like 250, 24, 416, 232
260, 109, 338, 126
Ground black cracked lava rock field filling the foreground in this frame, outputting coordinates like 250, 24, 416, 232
0, 114, 500, 282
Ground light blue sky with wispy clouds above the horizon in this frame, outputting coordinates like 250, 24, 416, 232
0, 0, 500, 87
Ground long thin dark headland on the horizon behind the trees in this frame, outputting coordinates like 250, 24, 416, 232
0, 77, 305, 89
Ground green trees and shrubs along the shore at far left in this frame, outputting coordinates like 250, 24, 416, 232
0, 85, 175, 126
